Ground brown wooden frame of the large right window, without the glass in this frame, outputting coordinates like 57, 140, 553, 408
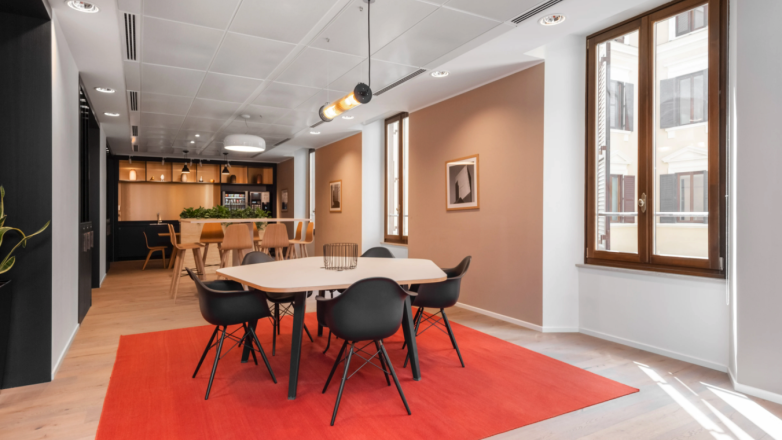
584, 0, 728, 278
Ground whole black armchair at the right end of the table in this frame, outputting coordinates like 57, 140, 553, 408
402, 257, 472, 368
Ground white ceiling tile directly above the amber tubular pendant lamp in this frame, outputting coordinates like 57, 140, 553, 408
277, 47, 363, 89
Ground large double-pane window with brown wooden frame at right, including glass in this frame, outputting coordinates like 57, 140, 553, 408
586, 0, 726, 277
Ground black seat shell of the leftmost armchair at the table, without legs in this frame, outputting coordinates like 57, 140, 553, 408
185, 268, 271, 325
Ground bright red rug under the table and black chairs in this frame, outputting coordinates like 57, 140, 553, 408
97, 313, 638, 440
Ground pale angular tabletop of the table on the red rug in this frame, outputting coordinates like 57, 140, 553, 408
217, 257, 447, 292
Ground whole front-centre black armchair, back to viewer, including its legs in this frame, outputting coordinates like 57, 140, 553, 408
316, 278, 415, 426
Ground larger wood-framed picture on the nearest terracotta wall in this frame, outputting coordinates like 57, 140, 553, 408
445, 154, 481, 211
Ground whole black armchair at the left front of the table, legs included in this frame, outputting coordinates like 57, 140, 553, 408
185, 268, 277, 400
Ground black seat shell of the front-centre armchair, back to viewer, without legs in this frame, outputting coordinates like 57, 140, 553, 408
318, 278, 414, 341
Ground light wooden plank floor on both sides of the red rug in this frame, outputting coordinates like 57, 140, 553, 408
0, 253, 782, 440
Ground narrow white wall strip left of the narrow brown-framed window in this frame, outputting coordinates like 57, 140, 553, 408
361, 119, 407, 258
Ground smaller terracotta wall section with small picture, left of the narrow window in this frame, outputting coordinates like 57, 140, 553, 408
315, 133, 361, 255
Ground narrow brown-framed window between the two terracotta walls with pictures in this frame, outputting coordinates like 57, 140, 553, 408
385, 113, 409, 244
